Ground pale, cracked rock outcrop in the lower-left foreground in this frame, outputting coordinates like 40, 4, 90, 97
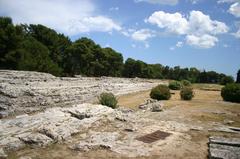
0, 104, 114, 151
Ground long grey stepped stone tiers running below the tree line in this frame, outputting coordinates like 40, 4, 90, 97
0, 70, 163, 118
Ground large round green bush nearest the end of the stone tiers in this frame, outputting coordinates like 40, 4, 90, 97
150, 85, 171, 100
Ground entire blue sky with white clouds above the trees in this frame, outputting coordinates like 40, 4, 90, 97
0, 0, 240, 77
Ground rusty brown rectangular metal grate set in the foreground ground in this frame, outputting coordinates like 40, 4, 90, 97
136, 130, 171, 143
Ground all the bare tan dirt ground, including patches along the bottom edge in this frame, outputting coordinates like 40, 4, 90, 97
7, 84, 240, 159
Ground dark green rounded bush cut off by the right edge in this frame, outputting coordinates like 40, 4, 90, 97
221, 83, 240, 103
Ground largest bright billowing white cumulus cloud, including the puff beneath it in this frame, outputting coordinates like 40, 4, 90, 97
145, 11, 229, 48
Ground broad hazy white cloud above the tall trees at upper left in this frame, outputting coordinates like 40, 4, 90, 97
0, 0, 121, 35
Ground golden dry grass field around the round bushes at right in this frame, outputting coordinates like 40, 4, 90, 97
118, 84, 240, 126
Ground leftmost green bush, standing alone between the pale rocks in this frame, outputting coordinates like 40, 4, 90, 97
98, 93, 117, 109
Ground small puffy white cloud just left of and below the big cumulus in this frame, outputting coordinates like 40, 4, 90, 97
131, 29, 155, 41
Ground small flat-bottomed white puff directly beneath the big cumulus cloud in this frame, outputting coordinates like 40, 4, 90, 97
186, 34, 218, 49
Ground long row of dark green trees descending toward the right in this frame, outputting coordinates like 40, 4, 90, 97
0, 17, 240, 84
